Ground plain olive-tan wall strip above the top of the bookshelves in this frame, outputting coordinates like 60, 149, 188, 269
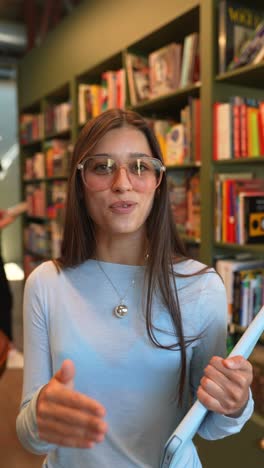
18, 0, 199, 108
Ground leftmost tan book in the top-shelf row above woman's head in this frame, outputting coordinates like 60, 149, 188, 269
125, 52, 150, 106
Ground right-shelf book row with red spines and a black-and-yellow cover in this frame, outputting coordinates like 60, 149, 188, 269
215, 172, 264, 245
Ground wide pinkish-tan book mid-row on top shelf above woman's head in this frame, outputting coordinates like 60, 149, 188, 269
149, 42, 182, 98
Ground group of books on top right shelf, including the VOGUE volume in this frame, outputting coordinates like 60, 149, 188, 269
218, 0, 264, 73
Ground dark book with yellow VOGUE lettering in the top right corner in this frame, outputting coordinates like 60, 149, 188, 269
218, 0, 264, 73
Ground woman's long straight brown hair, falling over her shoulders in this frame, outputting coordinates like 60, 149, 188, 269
57, 109, 201, 403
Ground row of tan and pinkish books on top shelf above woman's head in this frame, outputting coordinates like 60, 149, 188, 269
125, 32, 200, 105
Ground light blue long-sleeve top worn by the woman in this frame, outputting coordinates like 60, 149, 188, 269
17, 260, 253, 468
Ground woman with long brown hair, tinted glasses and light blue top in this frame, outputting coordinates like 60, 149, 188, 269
17, 110, 253, 468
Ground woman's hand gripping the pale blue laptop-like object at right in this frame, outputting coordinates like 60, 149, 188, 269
197, 356, 253, 417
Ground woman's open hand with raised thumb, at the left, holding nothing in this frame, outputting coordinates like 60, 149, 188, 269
37, 359, 107, 448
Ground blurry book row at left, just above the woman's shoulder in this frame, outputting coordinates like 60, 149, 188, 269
24, 221, 62, 258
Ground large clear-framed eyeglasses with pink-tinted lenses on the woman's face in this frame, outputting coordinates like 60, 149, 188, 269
77, 155, 166, 191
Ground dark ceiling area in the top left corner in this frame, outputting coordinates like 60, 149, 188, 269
0, 0, 83, 78
